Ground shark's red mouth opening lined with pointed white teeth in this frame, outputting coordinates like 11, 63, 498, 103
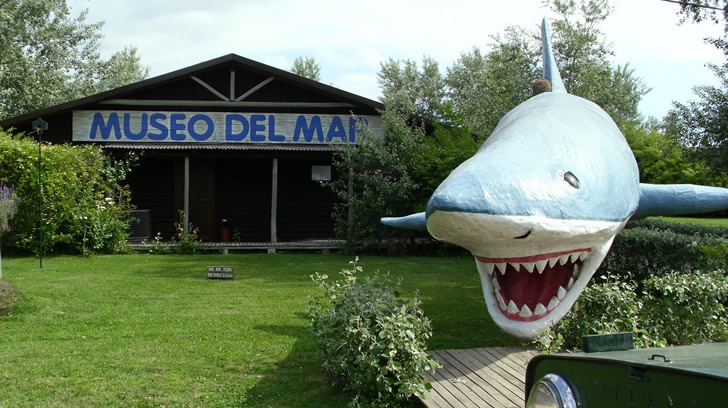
475, 248, 592, 322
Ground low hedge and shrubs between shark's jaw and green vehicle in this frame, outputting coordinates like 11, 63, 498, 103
535, 219, 728, 352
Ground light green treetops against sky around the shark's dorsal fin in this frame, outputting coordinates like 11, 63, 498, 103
378, 0, 649, 139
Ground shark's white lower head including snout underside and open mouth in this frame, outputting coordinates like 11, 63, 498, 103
427, 210, 626, 339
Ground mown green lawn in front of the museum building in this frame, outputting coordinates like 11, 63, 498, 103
0, 254, 520, 408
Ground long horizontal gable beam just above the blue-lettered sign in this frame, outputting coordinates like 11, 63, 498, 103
99, 99, 356, 108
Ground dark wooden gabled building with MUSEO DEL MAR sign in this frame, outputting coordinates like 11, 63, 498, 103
0, 54, 383, 242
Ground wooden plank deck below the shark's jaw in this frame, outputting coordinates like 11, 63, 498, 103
422, 347, 537, 408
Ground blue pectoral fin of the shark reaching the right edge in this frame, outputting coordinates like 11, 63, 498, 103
632, 184, 728, 219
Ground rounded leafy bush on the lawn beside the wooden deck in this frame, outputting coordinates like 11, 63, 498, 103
309, 260, 439, 407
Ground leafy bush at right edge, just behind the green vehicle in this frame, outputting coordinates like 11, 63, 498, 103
642, 271, 728, 344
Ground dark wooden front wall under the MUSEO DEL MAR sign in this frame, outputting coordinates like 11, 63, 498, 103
128, 152, 336, 242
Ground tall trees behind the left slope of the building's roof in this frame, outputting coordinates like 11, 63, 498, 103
0, 0, 149, 118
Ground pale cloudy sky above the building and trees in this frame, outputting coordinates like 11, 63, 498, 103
67, 0, 723, 119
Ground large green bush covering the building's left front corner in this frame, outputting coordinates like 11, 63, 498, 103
0, 131, 134, 252
